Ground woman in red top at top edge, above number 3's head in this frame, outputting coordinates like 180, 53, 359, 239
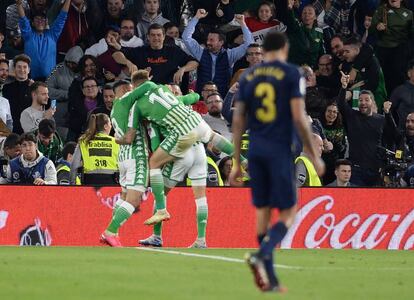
246, 1, 286, 45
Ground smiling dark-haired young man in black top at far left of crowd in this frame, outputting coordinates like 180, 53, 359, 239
3, 54, 33, 134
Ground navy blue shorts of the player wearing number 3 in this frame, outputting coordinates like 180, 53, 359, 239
248, 146, 296, 209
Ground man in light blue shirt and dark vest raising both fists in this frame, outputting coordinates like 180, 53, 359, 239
182, 9, 253, 95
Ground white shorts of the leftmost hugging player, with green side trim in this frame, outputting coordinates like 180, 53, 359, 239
118, 157, 148, 192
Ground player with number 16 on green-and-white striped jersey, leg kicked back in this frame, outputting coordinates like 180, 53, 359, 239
131, 70, 245, 225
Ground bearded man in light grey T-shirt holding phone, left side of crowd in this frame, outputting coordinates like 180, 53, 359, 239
20, 81, 56, 132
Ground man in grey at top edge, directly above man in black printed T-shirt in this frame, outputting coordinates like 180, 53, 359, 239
137, 0, 170, 41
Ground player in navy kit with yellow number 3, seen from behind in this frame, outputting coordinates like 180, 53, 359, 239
230, 32, 324, 292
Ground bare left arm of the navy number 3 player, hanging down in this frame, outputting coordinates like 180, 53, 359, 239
230, 101, 247, 186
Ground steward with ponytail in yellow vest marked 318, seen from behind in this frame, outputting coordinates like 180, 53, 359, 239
70, 114, 119, 185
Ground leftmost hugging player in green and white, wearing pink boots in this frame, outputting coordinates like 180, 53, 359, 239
101, 81, 148, 247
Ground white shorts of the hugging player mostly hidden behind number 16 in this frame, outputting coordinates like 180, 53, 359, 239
162, 143, 207, 188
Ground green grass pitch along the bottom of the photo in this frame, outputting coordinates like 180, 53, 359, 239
0, 247, 414, 300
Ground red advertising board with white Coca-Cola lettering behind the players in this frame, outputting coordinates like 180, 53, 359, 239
0, 186, 414, 250
